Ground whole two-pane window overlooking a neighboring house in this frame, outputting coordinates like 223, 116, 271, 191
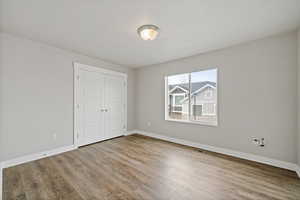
165, 69, 218, 126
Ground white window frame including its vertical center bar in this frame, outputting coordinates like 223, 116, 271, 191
164, 67, 219, 127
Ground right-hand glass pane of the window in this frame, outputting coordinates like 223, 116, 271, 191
191, 69, 217, 125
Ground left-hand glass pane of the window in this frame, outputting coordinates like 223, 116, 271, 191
168, 74, 189, 120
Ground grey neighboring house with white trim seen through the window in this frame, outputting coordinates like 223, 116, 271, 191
169, 81, 217, 116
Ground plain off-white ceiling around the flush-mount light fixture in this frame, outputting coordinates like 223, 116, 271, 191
0, 0, 300, 67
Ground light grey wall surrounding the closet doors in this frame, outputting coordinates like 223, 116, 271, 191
0, 33, 135, 161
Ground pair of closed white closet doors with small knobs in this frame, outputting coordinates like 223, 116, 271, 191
75, 65, 126, 146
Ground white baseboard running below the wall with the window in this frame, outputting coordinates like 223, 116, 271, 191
133, 130, 300, 177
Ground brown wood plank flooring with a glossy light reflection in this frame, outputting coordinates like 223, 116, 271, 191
3, 135, 300, 200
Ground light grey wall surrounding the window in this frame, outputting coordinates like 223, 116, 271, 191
136, 32, 297, 163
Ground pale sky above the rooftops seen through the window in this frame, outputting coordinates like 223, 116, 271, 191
168, 69, 217, 85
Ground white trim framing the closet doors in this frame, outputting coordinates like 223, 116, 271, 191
73, 62, 127, 147
